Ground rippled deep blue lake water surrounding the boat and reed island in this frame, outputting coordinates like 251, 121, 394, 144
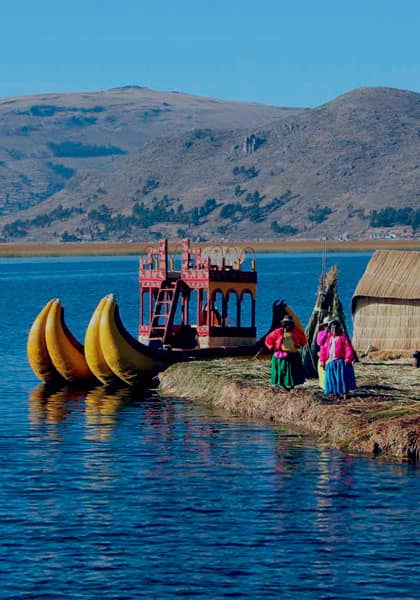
0, 253, 420, 600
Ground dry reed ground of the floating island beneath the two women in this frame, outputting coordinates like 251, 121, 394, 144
159, 359, 420, 461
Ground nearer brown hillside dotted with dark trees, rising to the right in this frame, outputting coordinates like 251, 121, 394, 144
3, 88, 420, 241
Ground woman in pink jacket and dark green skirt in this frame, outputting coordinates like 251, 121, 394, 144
264, 315, 306, 390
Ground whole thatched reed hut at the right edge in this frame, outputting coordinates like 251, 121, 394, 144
352, 250, 420, 351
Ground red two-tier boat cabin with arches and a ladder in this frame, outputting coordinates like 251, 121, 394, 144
139, 239, 257, 348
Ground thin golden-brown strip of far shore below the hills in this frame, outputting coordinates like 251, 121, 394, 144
0, 239, 420, 258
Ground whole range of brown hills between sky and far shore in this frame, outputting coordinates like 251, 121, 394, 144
0, 86, 420, 242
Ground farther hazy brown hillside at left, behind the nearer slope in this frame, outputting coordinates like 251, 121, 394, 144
0, 86, 297, 214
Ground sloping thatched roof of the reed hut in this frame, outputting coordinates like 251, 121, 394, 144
352, 250, 420, 312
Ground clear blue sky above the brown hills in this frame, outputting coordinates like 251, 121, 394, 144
0, 0, 420, 107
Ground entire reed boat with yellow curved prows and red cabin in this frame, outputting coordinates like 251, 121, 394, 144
27, 239, 302, 385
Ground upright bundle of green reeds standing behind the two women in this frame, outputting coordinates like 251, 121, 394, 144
302, 265, 350, 379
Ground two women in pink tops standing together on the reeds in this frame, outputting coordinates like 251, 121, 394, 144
265, 315, 356, 398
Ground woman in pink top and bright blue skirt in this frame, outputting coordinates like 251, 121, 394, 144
319, 321, 356, 398
